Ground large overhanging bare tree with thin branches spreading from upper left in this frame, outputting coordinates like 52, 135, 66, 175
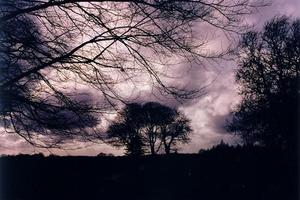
0, 0, 262, 146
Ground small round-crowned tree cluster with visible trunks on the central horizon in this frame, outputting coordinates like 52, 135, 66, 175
107, 102, 192, 156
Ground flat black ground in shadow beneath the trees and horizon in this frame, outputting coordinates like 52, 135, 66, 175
0, 147, 299, 200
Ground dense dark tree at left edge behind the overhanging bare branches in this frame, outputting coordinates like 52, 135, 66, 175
0, 9, 98, 147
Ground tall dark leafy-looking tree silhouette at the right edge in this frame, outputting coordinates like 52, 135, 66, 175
228, 17, 300, 149
